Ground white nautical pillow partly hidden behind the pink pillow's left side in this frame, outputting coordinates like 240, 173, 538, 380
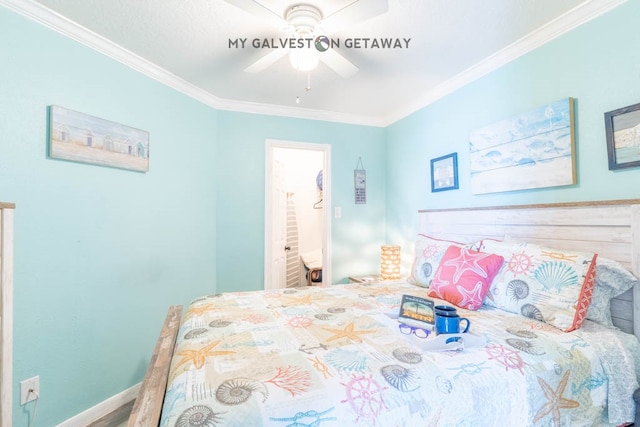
409, 234, 463, 288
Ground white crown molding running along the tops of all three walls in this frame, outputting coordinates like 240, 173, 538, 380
0, 0, 627, 127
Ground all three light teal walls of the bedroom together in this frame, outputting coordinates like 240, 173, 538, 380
0, 2, 640, 426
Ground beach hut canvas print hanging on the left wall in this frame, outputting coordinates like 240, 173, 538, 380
49, 105, 149, 172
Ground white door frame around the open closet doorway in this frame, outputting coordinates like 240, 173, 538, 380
264, 139, 331, 289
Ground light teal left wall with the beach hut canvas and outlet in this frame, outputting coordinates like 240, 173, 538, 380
0, 8, 217, 426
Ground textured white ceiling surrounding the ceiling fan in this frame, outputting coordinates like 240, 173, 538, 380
6, 0, 624, 125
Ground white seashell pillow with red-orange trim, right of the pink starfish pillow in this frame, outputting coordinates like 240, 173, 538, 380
472, 240, 597, 332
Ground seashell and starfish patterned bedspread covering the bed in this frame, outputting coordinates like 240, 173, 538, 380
160, 282, 640, 427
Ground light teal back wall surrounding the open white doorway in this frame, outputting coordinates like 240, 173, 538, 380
216, 111, 386, 292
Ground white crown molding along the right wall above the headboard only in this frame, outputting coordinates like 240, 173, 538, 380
382, 0, 627, 126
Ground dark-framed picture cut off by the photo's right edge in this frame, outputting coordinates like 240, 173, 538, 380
604, 104, 640, 170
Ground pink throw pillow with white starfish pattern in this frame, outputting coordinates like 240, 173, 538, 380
428, 246, 504, 310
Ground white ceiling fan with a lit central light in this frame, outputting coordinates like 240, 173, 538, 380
225, 0, 389, 78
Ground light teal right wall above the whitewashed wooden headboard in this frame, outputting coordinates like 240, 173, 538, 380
386, 1, 640, 271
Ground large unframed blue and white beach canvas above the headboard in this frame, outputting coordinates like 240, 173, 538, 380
469, 98, 576, 194
